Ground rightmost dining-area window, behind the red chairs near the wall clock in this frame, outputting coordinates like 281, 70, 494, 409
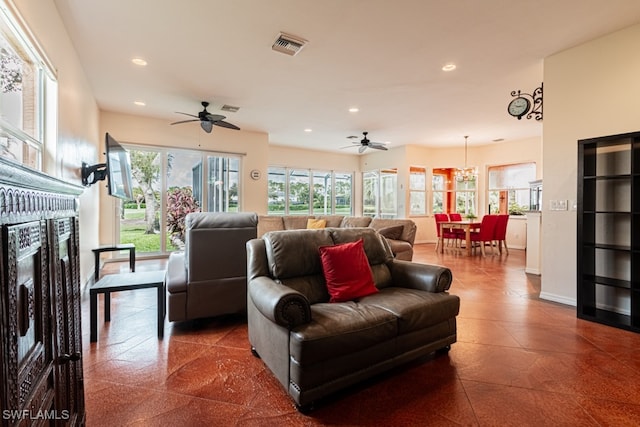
489, 163, 536, 215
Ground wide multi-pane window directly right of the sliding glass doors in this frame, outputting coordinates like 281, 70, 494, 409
267, 166, 353, 215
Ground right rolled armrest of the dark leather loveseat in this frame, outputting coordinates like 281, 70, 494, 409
390, 259, 453, 292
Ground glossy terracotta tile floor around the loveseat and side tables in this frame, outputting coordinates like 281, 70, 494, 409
83, 245, 640, 427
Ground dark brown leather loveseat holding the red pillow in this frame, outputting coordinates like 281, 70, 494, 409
247, 228, 460, 412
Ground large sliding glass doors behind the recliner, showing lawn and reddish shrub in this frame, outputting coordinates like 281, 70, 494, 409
119, 145, 241, 254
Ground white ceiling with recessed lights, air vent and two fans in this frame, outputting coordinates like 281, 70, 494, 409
54, 0, 640, 153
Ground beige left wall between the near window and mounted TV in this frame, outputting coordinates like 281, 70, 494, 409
14, 0, 98, 288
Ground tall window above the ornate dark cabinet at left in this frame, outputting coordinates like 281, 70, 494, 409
0, 2, 58, 170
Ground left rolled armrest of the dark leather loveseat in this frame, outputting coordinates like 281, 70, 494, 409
248, 276, 311, 329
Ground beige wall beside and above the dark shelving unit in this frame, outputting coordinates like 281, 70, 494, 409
541, 25, 640, 305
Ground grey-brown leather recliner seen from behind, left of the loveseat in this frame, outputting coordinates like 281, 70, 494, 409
165, 212, 258, 321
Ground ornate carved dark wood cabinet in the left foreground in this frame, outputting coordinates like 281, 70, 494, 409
0, 158, 85, 426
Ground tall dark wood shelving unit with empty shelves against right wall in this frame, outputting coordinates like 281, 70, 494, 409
577, 132, 640, 332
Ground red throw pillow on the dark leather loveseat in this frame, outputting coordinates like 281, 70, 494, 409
320, 239, 378, 302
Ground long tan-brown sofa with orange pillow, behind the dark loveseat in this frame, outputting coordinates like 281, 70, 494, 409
258, 215, 416, 261
